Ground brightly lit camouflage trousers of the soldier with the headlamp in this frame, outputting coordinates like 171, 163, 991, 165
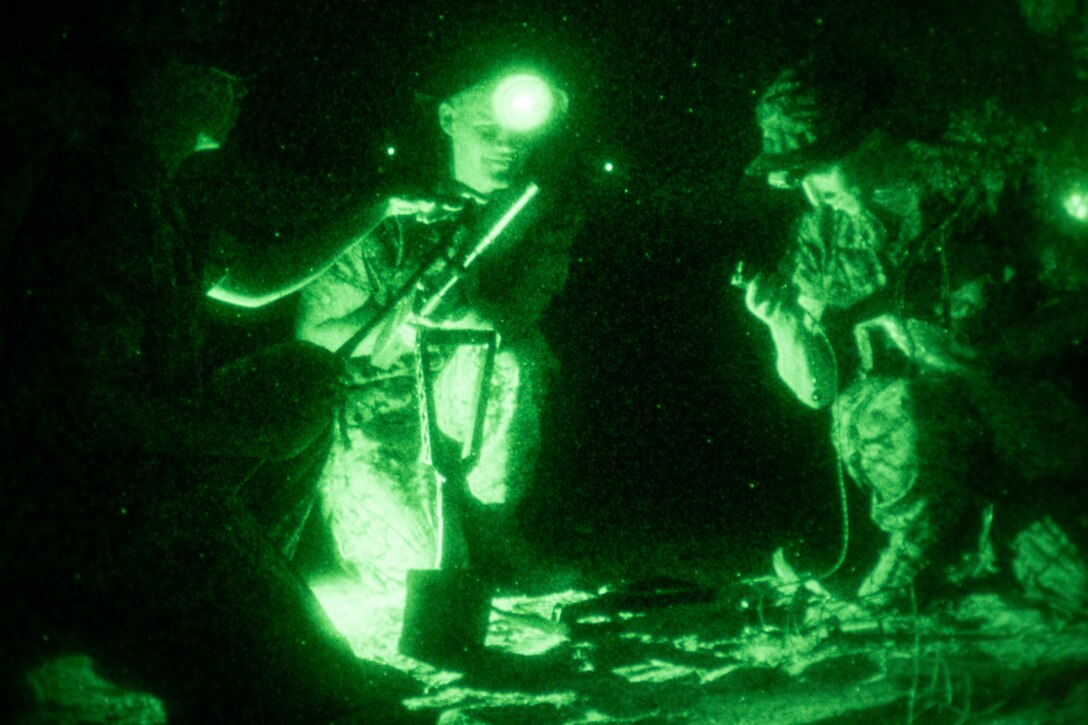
321, 341, 548, 592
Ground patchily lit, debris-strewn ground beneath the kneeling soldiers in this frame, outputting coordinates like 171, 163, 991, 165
17, 566, 1088, 725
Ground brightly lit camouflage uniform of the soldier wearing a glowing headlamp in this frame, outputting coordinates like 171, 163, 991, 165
302, 200, 570, 592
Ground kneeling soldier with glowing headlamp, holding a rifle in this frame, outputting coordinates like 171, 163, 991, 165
297, 60, 573, 592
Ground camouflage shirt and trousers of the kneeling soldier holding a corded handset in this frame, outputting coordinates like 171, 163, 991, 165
782, 166, 981, 594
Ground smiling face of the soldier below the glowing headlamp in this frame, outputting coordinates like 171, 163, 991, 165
438, 85, 529, 196
